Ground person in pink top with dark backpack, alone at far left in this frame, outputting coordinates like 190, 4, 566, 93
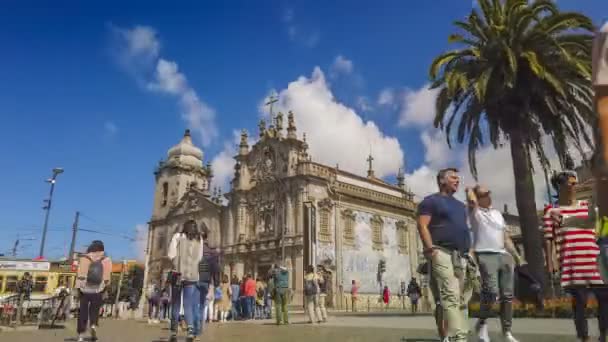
76, 240, 112, 342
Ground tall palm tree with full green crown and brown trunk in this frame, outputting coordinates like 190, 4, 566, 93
430, 0, 596, 282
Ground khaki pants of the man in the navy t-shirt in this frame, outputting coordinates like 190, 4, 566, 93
431, 248, 469, 342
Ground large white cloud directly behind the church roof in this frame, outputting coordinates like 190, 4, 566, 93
270, 67, 403, 177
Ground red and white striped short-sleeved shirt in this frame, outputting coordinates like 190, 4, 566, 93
543, 201, 604, 287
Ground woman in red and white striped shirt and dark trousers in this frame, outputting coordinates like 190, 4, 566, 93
543, 171, 608, 341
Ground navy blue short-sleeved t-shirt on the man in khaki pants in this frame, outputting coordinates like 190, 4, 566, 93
418, 193, 471, 252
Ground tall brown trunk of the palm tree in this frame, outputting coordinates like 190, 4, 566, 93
510, 128, 546, 285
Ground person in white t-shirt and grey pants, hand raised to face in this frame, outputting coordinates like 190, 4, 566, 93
466, 185, 520, 342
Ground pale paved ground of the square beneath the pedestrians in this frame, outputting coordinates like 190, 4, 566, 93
0, 315, 595, 342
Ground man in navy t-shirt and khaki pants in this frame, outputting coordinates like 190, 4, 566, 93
418, 168, 471, 342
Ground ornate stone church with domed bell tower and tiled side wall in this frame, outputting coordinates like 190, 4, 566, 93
146, 112, 422, 305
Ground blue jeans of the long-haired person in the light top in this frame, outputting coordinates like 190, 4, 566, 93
170, 283, 200, 333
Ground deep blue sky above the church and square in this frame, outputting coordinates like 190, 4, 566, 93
0, 0, 608, 258
